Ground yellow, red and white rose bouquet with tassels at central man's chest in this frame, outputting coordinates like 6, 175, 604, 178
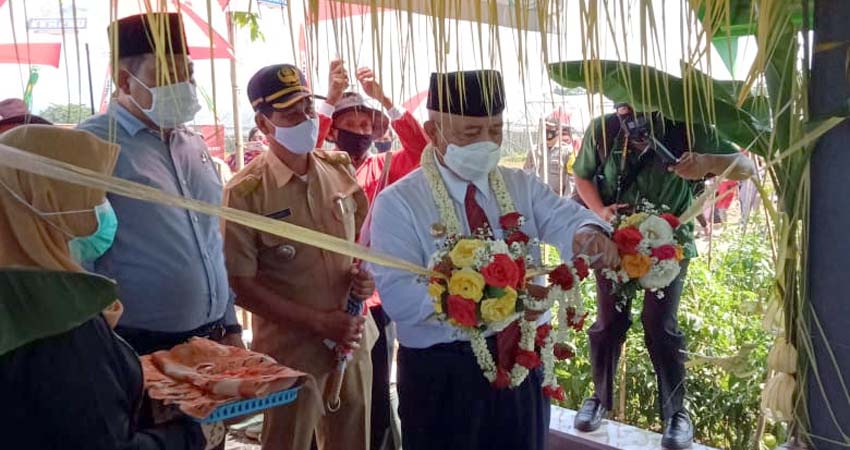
428, 212, 589, 399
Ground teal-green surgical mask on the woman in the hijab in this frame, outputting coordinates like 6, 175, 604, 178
0, 181, 118, 263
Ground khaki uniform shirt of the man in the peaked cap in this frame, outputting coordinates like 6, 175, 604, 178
224, 150, 377, 375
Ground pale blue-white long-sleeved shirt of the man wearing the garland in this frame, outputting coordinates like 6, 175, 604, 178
371, 156, 610, 348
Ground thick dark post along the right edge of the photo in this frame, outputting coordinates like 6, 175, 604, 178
800, 0, 850, 450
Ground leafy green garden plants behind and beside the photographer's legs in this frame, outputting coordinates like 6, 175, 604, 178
556, 215, 781, 450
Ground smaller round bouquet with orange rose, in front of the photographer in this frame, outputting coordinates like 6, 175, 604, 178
603, 203, 687, 308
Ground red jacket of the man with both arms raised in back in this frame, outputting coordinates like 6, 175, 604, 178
317, 111, 428, 308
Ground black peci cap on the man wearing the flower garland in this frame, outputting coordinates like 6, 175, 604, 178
428, 70, 505, 117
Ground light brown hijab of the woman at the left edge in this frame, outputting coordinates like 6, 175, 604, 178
0, 125, 119, 272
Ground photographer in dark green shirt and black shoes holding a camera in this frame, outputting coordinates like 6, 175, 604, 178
573, 103, 753, 449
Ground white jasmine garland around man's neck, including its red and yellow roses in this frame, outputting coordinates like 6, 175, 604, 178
421, 147, 587, 392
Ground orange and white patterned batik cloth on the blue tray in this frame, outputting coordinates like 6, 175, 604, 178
141, 338, 304, 419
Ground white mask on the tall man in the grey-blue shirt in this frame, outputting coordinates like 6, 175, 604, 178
127, 72, 201, 129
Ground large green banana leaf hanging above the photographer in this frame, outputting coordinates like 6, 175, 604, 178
549, 60, 771, 154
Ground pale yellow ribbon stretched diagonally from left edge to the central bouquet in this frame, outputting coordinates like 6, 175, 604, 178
0, 144, 434, 277
